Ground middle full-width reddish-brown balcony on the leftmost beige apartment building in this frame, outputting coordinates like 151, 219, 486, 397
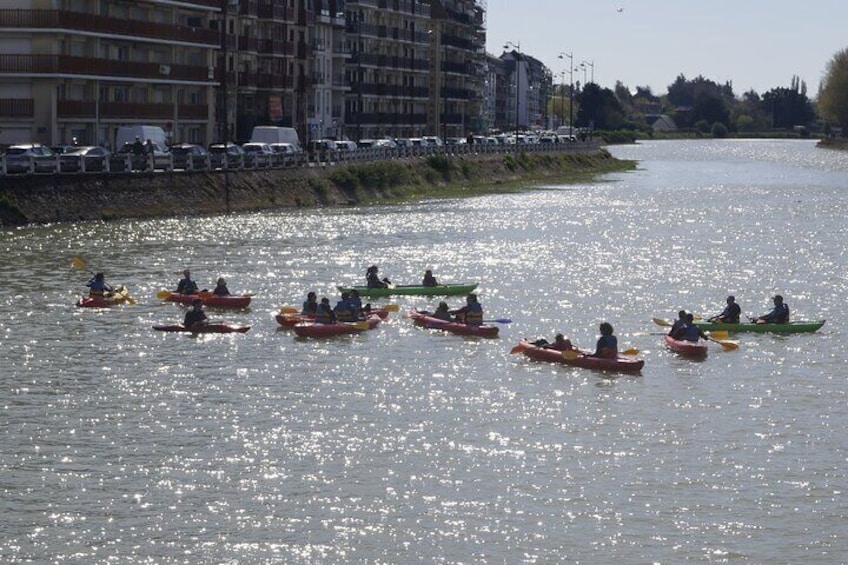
0, 55, 212, 83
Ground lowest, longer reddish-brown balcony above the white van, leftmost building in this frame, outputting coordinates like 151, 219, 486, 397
56, 100, 209, 120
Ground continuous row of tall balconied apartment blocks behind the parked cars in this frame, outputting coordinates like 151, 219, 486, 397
0, 0, 496, 149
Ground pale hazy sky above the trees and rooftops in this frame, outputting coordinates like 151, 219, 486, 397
487, 0, 848, 98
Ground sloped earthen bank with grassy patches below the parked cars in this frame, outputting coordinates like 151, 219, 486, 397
0, 149, 634, 225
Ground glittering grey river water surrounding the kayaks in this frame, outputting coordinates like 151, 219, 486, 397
0, 141, 848, 564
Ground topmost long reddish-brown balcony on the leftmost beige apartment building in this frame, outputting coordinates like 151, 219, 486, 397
0, 10, 221, 47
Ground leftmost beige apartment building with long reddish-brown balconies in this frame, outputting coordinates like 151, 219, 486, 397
0, 0, 221, 146
